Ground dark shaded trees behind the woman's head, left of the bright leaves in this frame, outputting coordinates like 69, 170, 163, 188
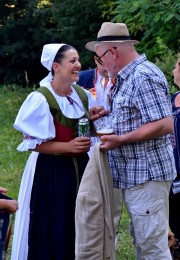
0, 0, 117, 83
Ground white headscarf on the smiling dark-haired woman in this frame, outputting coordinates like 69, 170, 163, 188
40, 43, 66, 86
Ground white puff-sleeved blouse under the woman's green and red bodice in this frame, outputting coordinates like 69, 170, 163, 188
14, 83, 97, 151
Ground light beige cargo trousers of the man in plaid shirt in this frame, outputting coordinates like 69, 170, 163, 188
123, 181, 172, 260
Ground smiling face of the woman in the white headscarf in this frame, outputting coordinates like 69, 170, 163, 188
54, 49, 81, 84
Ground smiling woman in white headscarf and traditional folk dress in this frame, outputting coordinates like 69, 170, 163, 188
11, 44, 103, 260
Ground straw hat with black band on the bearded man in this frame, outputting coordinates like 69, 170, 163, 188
85, 22, 139, 52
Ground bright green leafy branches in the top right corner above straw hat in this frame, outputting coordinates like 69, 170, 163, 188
113, 0, 180, 60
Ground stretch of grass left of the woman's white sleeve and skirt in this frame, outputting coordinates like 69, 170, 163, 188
0, 87, 30, 199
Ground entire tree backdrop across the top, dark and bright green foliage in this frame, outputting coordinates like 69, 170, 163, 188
0, 0, 180, 86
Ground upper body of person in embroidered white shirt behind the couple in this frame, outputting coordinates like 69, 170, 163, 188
77, 54, 114, 109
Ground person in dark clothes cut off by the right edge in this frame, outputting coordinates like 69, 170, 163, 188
169, 60, 180, 246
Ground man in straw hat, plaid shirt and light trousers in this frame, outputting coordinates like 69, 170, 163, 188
86, 22, 176, 260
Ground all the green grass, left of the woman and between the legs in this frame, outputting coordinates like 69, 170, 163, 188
0, 86, 135, 260
